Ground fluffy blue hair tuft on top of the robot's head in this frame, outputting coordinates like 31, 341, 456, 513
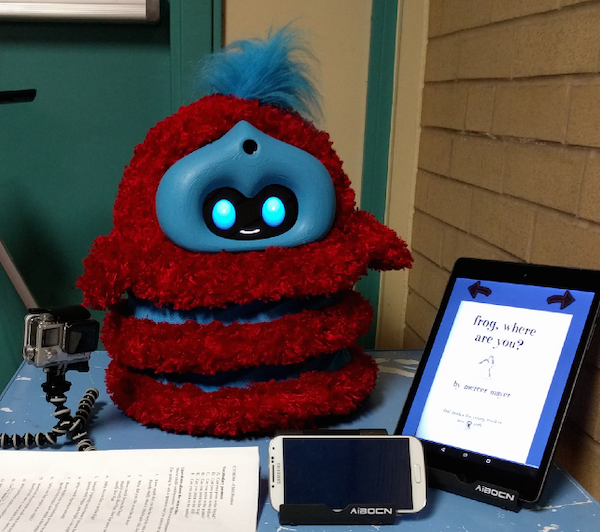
202, 26, 321, 118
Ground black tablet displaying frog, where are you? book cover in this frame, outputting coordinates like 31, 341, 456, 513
396, 259, 600, 502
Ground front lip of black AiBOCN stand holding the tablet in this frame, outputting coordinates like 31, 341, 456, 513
427, 467, 521, 512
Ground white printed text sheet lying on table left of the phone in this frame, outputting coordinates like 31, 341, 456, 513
0, 447, 259, 532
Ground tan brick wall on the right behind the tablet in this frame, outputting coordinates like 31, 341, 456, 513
404, 0, 600, 500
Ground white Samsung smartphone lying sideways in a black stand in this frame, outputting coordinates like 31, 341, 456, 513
269, 435, 427, 513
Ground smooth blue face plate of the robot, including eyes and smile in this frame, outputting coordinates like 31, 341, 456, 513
156, 121, 335, 252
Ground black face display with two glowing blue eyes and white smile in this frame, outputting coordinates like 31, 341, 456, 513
202, 185, 298, 240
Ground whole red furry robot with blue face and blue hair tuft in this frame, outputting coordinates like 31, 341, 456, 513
78, 30, 412, 436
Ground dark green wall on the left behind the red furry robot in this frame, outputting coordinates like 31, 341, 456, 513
0, 0, 221, 389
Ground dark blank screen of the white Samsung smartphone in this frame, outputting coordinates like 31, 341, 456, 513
283, 437, 413, 510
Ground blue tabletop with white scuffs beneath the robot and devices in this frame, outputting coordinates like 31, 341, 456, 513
0, 351, 600, 532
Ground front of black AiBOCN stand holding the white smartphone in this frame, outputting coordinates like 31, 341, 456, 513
279, 504, 396, 525
